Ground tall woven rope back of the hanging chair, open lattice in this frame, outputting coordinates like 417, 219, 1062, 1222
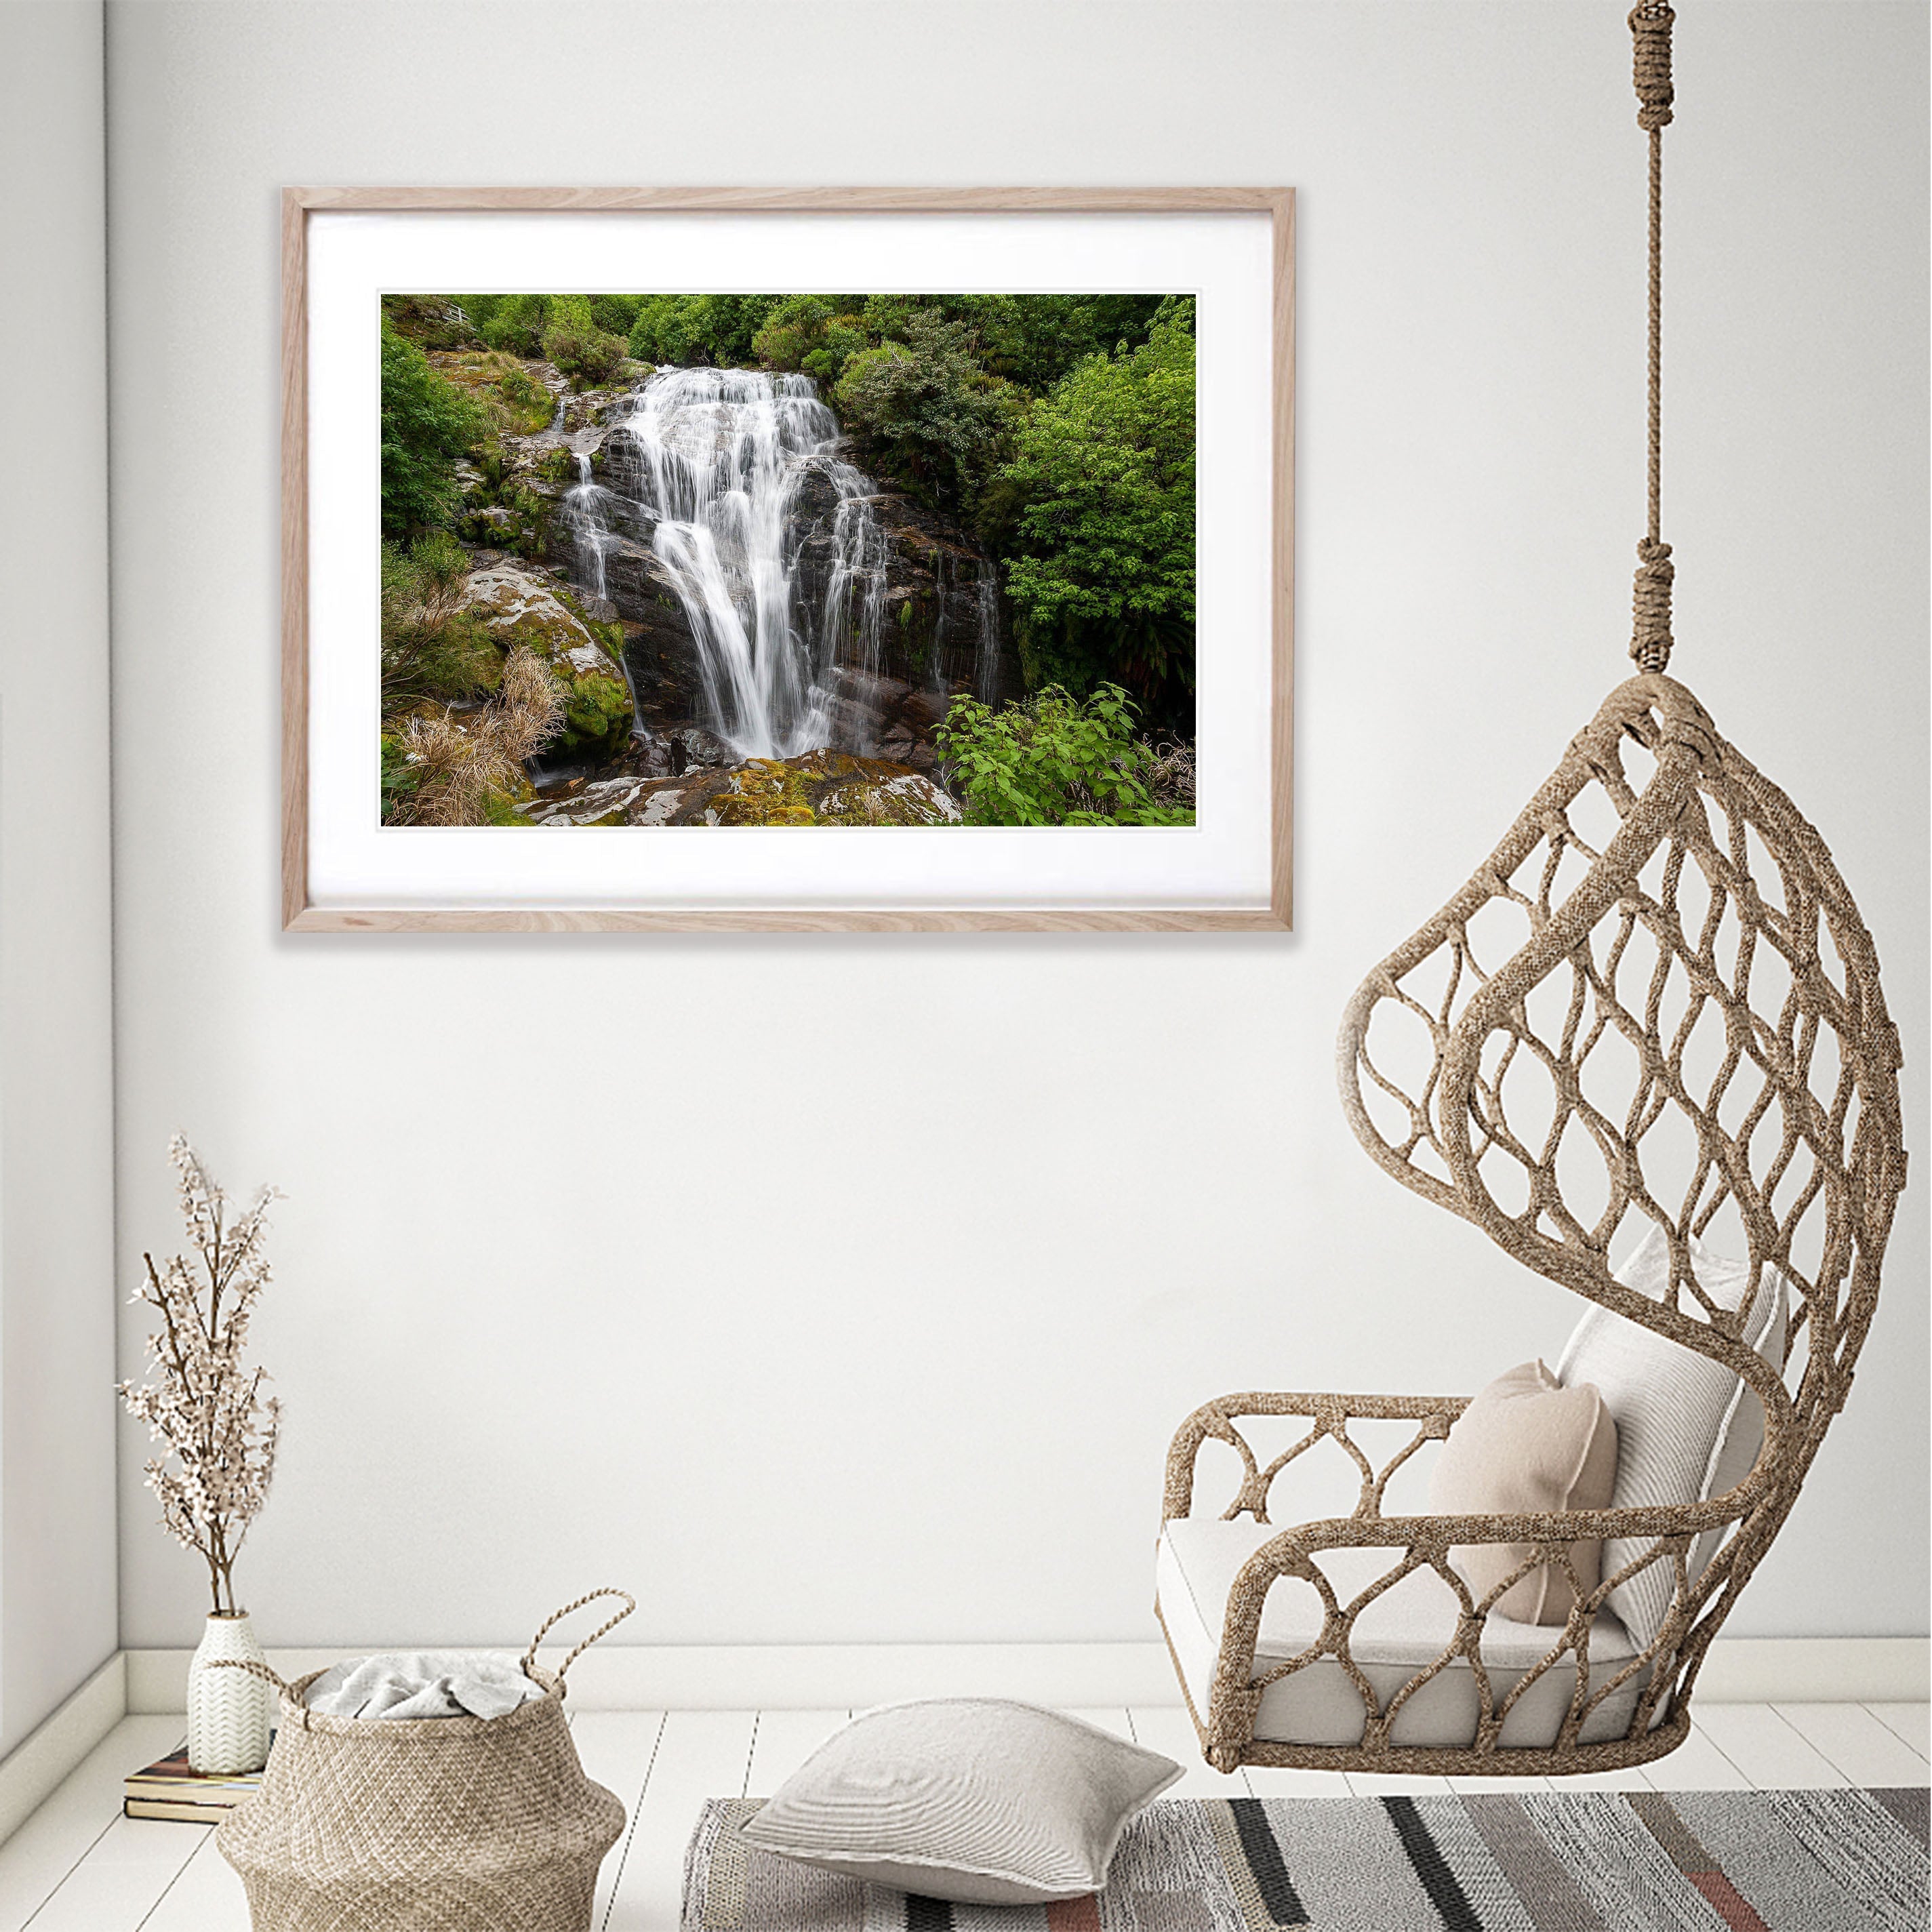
1341, 675, 1905, 1696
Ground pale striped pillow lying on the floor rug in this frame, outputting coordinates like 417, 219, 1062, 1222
740, 1698, 1180, 1905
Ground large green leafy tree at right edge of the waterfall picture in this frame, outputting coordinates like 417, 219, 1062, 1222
999, 298, 1194, 723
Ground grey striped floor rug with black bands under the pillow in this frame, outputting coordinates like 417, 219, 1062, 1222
684, 1789, 1926, 1932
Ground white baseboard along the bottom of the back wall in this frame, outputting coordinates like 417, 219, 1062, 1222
123, 1636, 1932, 1712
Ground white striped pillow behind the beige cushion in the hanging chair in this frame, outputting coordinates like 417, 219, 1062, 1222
1557, 1227, 1789, 1648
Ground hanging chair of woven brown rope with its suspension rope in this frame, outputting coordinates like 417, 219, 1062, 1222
1161, 0, 1905, 1775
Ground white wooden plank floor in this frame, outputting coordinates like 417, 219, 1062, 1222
0, 1704, 1932, 1932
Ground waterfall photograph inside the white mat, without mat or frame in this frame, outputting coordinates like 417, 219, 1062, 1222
380, 291, 1196, 829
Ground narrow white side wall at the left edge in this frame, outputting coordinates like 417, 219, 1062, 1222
0, 4, 116, 1752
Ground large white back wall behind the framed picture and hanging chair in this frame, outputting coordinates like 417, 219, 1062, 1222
108, 0, 1928, 1644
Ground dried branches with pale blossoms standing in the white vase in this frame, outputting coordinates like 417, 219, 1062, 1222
120, 1134, 282, 1615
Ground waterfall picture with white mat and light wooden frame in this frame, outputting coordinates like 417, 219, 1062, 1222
282, 187, 1295, 931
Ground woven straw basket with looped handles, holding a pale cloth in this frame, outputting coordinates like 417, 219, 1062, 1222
214, 1590, 636, 1932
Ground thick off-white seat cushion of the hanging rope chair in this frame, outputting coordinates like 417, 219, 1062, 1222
1155, 1516, 1644, 1748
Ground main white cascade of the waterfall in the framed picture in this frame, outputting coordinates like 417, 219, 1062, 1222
603, 369, 887, 757
